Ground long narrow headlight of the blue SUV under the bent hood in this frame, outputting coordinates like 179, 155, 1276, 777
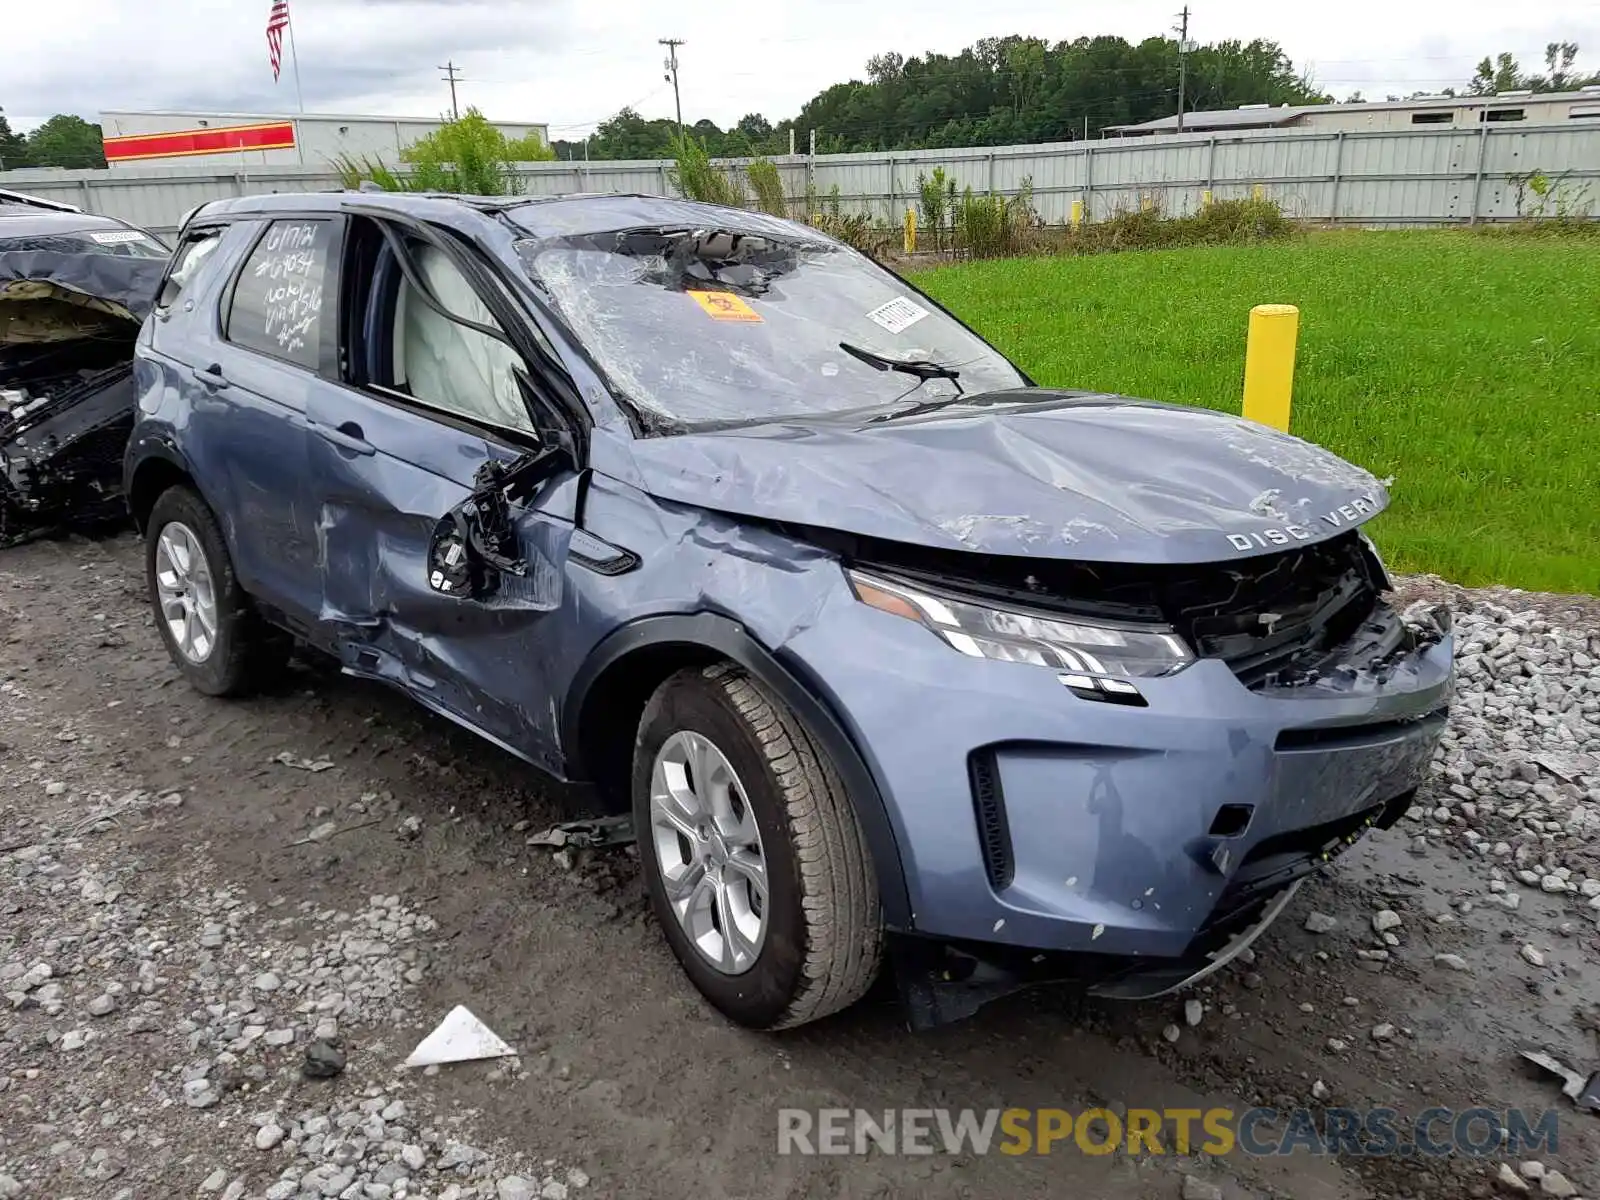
846, 570, 1194, 678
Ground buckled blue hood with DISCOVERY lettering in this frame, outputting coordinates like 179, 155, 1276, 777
617, 389, 1389, 563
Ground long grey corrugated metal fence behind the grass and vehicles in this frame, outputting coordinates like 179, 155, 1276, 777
0, 125, 1600, 232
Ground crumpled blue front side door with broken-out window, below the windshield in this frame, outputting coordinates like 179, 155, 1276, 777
307, 218, 576, 762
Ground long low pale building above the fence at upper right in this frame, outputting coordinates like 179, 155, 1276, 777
1106, 86, 1600, 138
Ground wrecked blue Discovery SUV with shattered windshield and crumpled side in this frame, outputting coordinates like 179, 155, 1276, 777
125, 192, 1451, 1029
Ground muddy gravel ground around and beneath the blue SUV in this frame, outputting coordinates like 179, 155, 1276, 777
0, 536, 1600, 1200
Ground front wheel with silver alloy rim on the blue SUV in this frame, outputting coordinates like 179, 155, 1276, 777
632, 664, 883, 1029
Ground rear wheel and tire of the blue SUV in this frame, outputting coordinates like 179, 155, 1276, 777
144, 486, 293, 696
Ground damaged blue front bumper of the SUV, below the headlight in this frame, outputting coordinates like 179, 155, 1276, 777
774, 550, 1451, 1024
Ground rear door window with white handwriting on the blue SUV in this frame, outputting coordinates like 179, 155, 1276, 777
224, 219, 334, 370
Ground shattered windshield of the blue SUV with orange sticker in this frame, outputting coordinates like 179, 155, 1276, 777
520, 229, 1026, 429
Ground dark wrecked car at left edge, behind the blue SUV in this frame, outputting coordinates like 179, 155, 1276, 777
0, 192, 168, 546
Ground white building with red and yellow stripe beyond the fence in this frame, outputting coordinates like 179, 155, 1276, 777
101, 112, 550, 170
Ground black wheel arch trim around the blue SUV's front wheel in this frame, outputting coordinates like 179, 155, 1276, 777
562, 613, 912, 930
